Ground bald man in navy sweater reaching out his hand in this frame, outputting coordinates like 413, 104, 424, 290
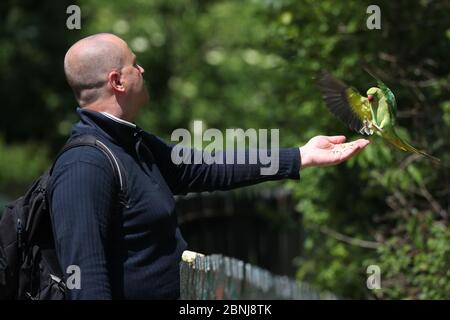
48, 34, 368, 299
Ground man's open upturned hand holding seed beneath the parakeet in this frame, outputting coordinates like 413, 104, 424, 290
300, 136, 370, 168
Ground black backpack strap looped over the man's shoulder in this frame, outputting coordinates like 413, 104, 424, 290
49, 134, 127, 196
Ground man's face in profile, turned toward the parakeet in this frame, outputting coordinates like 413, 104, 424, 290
121, 46, 149, 110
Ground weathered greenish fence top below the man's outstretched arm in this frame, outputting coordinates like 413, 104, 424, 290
180, 251, 337, 300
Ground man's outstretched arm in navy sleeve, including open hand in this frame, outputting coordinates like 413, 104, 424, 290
147, 131, 369, 194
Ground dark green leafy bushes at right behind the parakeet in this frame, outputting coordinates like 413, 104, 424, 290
256, 1, 450, 299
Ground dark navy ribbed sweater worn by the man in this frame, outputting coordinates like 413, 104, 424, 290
48, 109, 300, 299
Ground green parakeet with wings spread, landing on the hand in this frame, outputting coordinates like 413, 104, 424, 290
318, 71, 439, 162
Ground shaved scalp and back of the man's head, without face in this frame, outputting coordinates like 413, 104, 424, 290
64, 33, 129, 106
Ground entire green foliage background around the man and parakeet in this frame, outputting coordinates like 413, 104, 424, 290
0, 0, 450, 299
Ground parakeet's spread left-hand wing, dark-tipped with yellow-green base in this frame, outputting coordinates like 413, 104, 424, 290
318, 71, 372, 133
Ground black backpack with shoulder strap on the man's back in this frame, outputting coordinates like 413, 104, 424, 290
0, 135, 126, 300
